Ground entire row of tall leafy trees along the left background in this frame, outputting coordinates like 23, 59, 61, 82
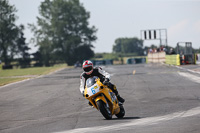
0, 0, 97, 67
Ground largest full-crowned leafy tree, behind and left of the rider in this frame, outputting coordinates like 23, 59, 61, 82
31, 0, 96, 65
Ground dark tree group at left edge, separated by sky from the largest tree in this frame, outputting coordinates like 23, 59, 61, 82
0, 0, 30, 67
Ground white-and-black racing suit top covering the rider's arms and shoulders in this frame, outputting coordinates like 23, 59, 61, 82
80, 67, 110, 94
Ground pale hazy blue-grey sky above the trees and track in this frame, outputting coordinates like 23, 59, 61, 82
9, 0, 200, 53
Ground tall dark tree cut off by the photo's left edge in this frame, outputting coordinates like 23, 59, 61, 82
0, 0, 19, 66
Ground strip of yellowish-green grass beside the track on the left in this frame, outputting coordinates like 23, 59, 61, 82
0, 64, 67, 86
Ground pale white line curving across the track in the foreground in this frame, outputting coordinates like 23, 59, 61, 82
55, 107, 200, 133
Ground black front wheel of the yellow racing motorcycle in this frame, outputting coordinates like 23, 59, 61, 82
97, 100, 112, 120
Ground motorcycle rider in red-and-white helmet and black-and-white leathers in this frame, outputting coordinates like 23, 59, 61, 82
80, 60, 125, 103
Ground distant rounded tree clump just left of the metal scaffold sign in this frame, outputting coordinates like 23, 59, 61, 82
113, 38, 143, 55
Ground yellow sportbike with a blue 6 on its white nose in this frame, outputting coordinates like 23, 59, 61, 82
84, 76, 125, 119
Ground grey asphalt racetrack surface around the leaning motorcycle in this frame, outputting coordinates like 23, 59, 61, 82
0, 64, 200, 133
